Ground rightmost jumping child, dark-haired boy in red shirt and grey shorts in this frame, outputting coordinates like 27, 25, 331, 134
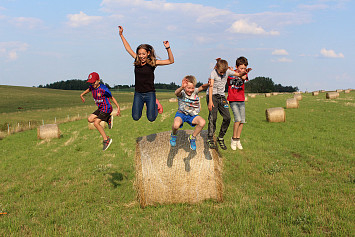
227, 57, 252, 150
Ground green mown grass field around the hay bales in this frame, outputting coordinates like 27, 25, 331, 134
0, 86, 355, 236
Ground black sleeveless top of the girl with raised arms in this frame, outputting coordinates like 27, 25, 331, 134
134, 63, 155, 93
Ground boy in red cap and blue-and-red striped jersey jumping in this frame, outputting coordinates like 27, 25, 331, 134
80, 72, 120, 151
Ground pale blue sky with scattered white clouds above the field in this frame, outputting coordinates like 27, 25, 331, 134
0, 0, 355, 91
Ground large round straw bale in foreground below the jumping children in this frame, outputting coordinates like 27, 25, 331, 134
136, 130, 223, 207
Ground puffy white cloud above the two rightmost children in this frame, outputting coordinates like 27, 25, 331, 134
227, 20, 280, 35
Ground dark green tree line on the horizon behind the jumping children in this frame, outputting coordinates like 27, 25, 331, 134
38, 77, 298, 93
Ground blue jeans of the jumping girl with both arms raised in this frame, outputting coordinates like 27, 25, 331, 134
132, 91, 158, 122
